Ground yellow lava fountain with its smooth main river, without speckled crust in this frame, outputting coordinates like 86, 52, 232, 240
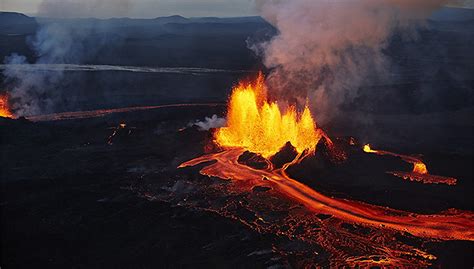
179, 75, 474, 237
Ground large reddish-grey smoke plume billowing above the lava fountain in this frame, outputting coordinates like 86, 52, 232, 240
252, 0, 462, 123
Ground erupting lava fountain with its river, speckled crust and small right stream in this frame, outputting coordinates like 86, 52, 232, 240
165, 75, 474, 267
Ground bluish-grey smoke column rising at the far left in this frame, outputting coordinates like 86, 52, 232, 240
3, 23, 87, 116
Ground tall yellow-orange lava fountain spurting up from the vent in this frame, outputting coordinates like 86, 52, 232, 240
215, 73, 323, 157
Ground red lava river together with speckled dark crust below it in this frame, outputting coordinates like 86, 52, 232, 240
173, 142, 474, 267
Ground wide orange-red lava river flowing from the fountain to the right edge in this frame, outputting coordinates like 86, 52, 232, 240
179, 148, 474, 241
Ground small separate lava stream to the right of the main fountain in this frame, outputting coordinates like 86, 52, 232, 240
364, 144, 457, 185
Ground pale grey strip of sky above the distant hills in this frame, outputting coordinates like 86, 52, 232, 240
0, 0, 256, 18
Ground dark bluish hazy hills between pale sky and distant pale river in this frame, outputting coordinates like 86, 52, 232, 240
0, 12, 276, 70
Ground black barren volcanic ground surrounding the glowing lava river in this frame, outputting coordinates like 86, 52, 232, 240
0, 101, 474, 268
